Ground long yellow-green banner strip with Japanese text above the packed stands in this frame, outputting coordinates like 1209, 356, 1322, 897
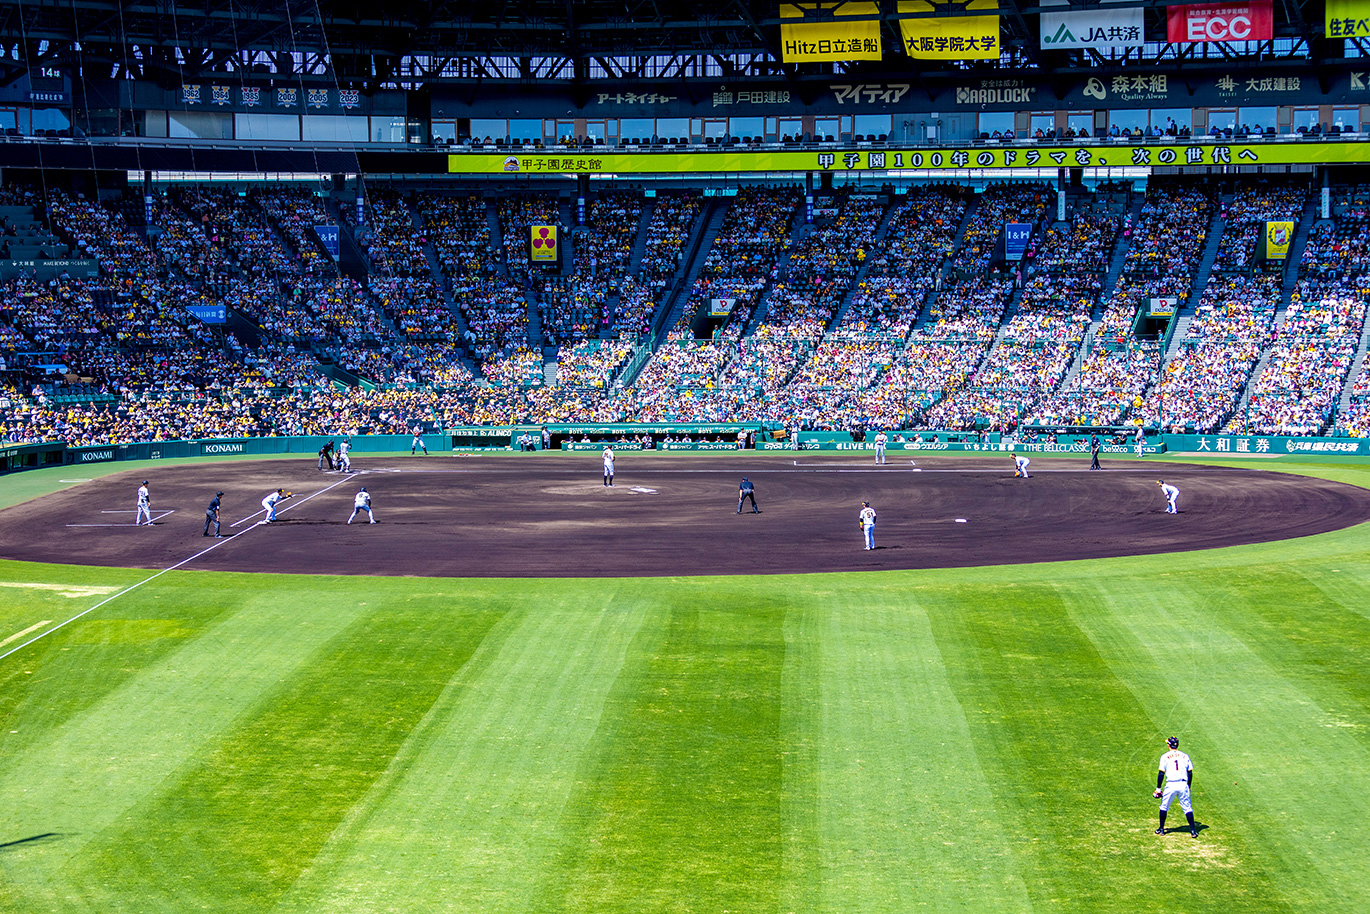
447, 140, 1370, 174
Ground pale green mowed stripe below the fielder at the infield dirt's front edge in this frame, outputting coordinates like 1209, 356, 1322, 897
785, 597, 1030, 914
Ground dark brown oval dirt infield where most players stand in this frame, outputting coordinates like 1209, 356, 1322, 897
0, 451, 1370, 577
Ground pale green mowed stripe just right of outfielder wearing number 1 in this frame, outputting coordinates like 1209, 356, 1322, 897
1079, 570, 1370, 911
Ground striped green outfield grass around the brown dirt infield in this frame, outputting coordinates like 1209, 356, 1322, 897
0, 460, 1370, 914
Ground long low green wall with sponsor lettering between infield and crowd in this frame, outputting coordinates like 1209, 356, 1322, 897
0, 423, 1370, 473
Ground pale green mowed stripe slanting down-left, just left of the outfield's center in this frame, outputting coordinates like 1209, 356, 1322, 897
275, 594, 647, 914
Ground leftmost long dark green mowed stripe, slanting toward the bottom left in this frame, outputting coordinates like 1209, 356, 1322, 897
49, 599, 501, 913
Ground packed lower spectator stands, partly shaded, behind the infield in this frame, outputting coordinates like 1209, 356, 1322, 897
0, 175, 1370, 445
